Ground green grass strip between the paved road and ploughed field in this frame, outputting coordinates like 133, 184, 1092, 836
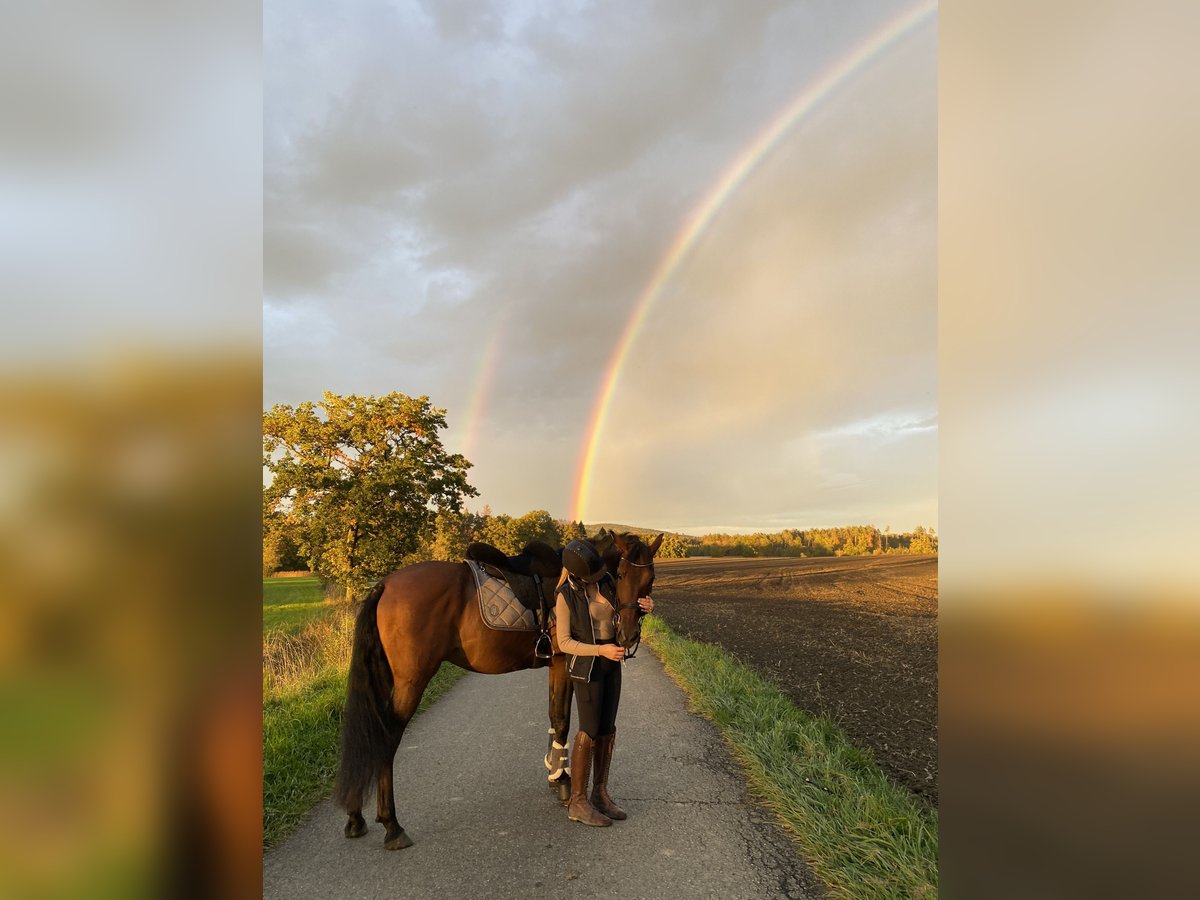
642, 616, 937, 898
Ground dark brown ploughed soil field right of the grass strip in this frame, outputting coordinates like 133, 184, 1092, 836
654, 556, 937, 806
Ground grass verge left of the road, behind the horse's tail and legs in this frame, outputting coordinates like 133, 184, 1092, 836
263, 588, 466, 850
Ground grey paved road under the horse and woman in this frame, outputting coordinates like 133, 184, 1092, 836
263, 647, 822, 900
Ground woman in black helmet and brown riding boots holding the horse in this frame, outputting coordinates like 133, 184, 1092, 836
554, 540, 654, 826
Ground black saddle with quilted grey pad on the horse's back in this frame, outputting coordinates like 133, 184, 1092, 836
466, 541, 562, 659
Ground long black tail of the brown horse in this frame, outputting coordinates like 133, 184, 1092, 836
334, 582, 400, 812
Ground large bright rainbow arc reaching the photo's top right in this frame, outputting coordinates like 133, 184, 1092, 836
571, 0, 937, 521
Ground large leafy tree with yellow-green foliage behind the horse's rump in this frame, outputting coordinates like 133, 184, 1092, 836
263, 391, 476, 595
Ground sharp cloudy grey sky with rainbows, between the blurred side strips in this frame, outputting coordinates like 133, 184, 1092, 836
263, 0, 937, 534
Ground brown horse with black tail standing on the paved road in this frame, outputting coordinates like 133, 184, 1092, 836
334, 533, 662, 850
